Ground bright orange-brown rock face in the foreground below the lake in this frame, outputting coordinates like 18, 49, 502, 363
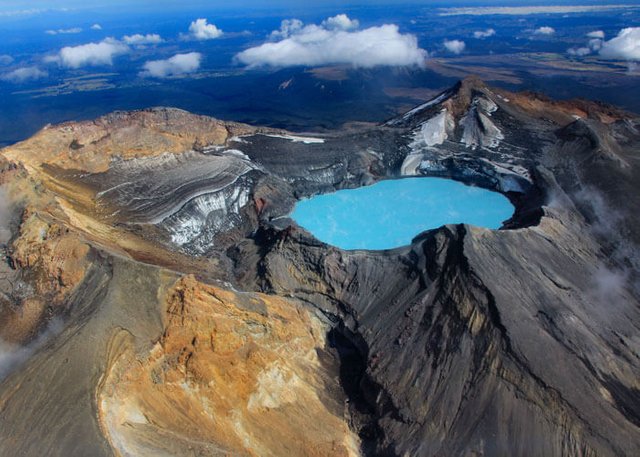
98, 277, 359, 456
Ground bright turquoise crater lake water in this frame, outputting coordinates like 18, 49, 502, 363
290, 178, 514, 250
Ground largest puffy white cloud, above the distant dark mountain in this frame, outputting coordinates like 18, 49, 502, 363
236, 15, 427, 68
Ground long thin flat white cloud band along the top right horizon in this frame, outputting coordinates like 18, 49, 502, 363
439, 5, 635, 16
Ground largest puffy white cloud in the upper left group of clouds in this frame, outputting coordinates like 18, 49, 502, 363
52, 38, 129, 68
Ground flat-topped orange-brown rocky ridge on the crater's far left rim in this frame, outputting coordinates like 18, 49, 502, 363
4, 108, 256, 173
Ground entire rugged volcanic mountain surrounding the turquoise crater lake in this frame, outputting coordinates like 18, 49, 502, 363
0, 79, 640, 456
